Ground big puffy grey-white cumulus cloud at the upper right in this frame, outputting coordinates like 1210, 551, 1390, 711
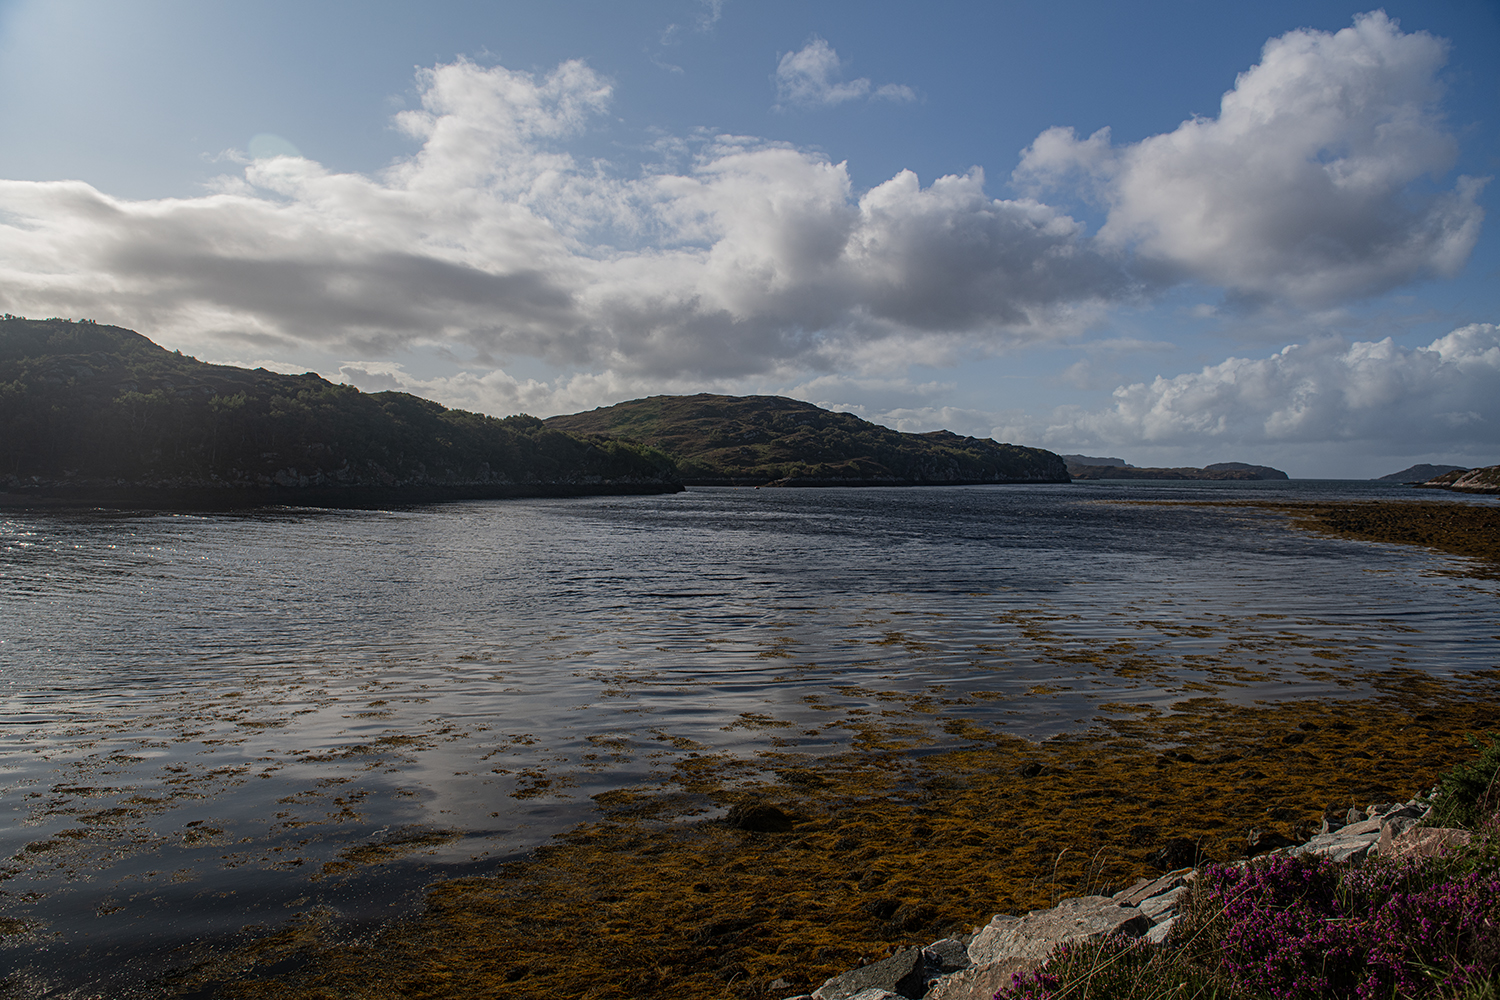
1016, 10, 1484, 307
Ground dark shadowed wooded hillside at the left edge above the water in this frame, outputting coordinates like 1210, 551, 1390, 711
0, 318, 680, 502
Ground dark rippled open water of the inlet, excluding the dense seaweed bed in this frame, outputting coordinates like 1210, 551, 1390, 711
0, 481, 1500, 996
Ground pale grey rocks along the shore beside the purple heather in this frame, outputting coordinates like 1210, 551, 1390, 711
771, 799, 1469, 1000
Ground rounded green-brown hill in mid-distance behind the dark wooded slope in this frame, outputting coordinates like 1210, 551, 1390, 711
546, 393, 1068, 486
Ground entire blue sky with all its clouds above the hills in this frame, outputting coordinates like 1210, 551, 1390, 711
0, 0, 1500, 478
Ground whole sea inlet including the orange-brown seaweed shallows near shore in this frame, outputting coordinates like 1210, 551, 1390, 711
0, 481, 1500, 997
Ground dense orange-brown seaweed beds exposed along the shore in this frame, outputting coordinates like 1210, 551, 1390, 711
0, 501, 1500, 999
